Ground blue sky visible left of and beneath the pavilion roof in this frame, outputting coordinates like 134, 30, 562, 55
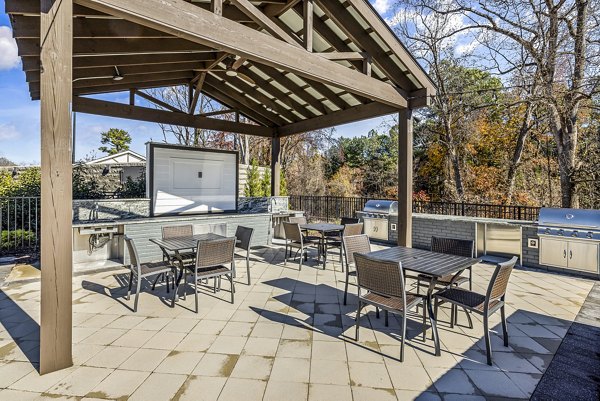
0, 0, 392, 164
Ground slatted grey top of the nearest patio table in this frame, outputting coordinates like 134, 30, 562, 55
367, 246, 481, 277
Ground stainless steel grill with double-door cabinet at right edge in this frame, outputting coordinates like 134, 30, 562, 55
538, 208, 600, 274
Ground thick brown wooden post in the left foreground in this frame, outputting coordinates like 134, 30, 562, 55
40, 0, 73, 374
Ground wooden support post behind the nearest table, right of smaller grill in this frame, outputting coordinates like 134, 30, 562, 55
398, 109, 413, 248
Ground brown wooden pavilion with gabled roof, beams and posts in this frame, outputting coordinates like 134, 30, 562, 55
5, 0, 435, 374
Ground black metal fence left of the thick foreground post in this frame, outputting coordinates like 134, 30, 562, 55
0, 197, 40, 255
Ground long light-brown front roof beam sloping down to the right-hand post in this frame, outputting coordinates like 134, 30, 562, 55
76, 0, 408, 108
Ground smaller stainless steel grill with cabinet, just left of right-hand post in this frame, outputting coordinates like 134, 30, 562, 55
356, 200, 398, 241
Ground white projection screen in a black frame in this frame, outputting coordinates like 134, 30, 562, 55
146, 143, 238, 216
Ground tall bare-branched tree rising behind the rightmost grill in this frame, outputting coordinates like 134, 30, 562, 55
425, 0, 600, 207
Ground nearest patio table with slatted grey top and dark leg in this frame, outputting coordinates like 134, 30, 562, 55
367, 246, 481, 356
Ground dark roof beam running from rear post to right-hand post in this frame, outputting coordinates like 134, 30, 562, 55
277, 102, 398, 137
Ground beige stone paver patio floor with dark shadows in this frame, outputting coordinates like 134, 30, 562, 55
0, 242, 593, 401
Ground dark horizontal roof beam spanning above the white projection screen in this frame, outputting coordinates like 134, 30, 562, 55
73, 97, 273, 137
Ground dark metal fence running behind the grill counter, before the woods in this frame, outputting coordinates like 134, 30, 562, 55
290, 195, 540, 221
